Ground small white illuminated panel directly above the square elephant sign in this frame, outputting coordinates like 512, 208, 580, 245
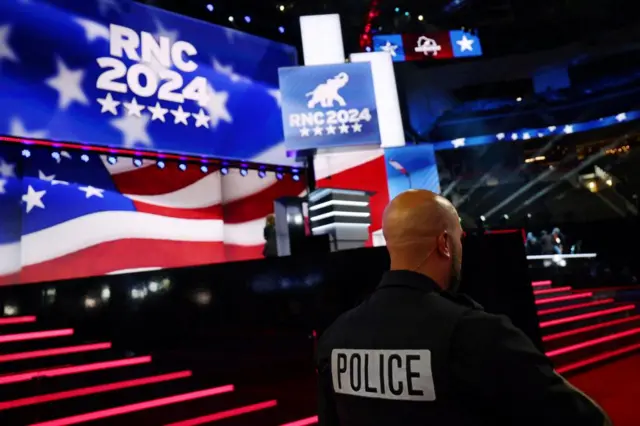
300, 14, 345, 65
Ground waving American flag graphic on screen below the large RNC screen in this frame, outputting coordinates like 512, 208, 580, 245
0, 146, 305, 284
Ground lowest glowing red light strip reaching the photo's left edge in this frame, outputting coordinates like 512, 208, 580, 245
0, 371, 191, 411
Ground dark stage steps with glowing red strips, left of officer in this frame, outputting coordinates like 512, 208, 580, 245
0, 316, 317, 426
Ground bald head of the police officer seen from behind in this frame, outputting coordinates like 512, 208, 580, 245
382, 190, 462, 288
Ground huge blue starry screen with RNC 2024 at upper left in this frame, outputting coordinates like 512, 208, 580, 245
0, 0, 297, 163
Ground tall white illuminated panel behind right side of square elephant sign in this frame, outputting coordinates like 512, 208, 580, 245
350, 52, 405, 148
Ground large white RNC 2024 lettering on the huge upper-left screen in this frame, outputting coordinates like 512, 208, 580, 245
96, 24, 209, 111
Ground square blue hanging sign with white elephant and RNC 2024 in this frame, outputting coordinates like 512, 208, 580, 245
279, 63, 380, 150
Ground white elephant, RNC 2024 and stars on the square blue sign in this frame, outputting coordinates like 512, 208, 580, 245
289, 72, 371, 137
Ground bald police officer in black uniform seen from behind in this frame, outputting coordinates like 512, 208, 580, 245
318, 190, 610, 426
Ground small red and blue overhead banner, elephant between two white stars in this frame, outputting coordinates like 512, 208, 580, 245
373, 30, 482, 62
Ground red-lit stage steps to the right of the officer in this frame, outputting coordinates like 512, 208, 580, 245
532, 280, 640, 374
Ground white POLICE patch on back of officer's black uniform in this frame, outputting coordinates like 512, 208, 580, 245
331, 349, 436, 401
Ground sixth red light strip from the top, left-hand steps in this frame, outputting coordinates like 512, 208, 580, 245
31, 385, 234, 426
